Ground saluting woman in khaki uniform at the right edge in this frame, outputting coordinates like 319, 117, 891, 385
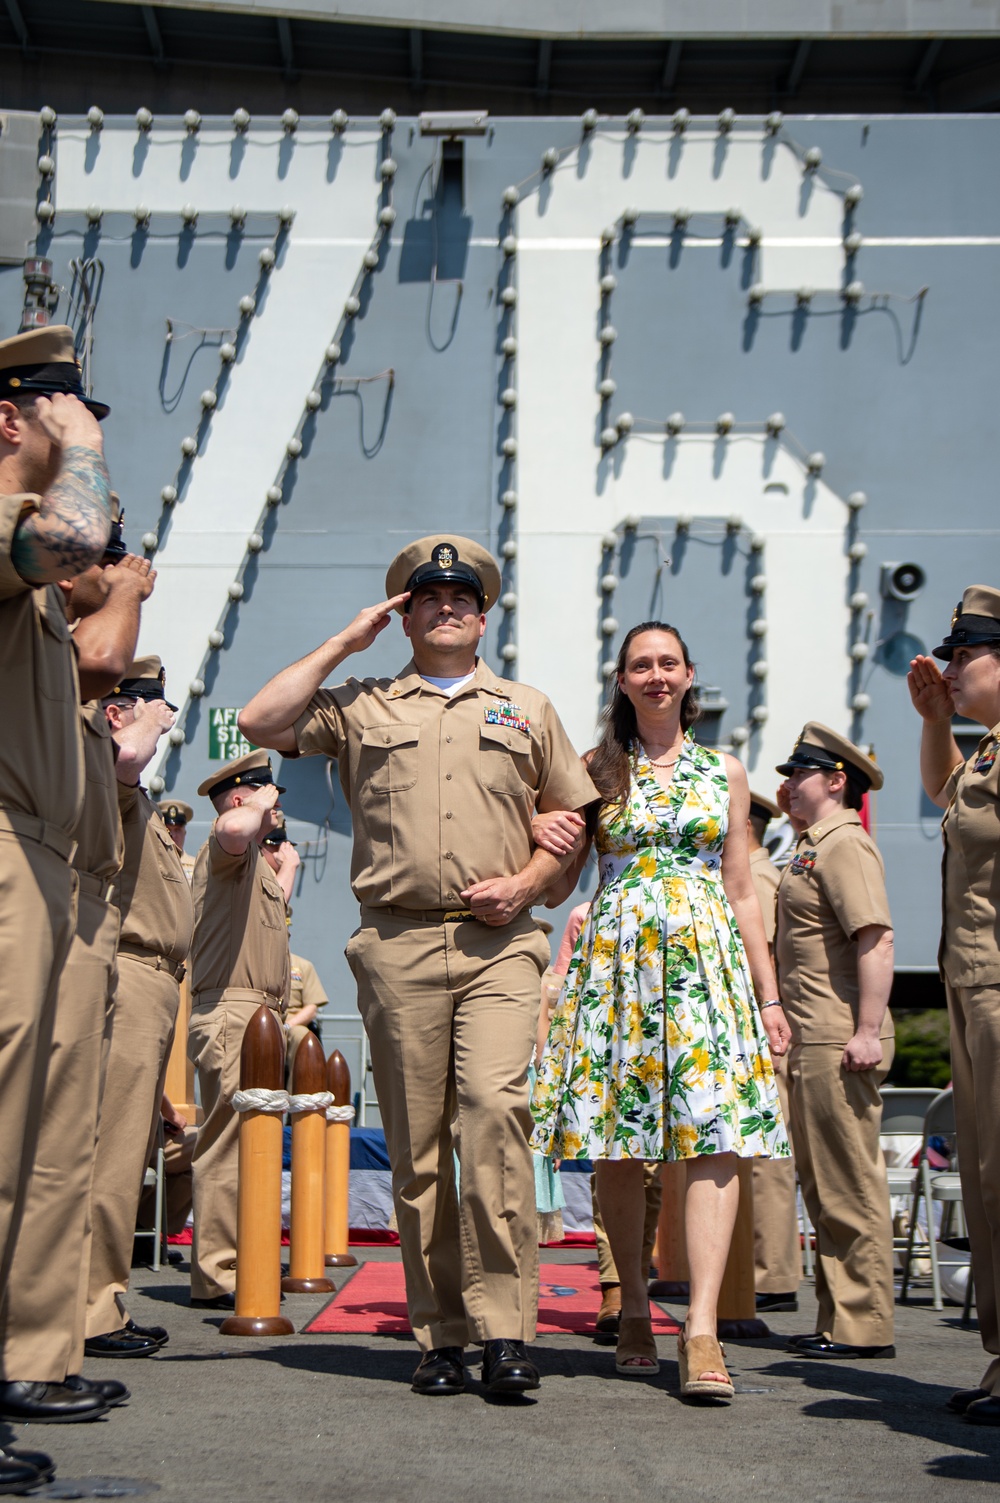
910, 585, 1000, 1425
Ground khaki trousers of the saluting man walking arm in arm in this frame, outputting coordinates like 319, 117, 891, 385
346, 909, 550, 1351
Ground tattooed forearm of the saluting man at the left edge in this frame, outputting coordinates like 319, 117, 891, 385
11, 445, 111, 585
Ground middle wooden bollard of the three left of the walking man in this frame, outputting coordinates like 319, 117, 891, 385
281, 1033, 334, 1294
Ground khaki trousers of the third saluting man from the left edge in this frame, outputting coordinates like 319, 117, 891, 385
87, 954, 180, 1336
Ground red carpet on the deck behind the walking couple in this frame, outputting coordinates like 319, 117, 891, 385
305, 1263, 678, 1336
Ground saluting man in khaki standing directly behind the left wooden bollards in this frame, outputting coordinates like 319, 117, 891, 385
188, 752, 292, 1309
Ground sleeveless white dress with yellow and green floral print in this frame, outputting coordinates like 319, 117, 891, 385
532, 735, 789, 1159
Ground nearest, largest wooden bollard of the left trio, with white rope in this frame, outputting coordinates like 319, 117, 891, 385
220, 1004, 295, 1336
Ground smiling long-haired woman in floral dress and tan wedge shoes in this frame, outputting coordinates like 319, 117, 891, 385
534, 622, 789, 1402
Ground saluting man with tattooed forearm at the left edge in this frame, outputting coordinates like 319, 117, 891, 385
0, 325, 111, 1454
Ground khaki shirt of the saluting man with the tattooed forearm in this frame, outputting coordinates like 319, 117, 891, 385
0, 496, 84, 836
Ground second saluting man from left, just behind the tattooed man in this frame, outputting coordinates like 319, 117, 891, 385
0, 522, 156, 1419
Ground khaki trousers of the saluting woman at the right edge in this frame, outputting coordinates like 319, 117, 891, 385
946, 983, 1000, 1393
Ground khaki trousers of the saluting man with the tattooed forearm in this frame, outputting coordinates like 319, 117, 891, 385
0, 821, 77, 1316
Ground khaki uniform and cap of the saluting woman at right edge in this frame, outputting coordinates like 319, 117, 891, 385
934, 585, 1000, 1396
